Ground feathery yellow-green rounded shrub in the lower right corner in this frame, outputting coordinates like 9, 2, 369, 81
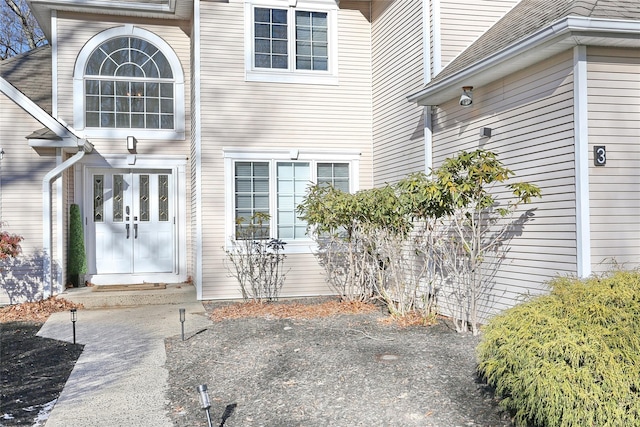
478, 271, 640, 427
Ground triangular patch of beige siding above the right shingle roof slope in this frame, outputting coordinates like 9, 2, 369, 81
438, 0, 519, 68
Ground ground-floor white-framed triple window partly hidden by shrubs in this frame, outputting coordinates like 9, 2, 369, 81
225, 152, 358, 249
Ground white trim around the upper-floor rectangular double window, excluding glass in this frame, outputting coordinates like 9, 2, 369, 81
244, 0, 338, 85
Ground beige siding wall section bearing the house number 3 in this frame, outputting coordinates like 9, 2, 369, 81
587, 48, 640, 272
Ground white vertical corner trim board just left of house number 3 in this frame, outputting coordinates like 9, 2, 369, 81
573, 46, 591, 278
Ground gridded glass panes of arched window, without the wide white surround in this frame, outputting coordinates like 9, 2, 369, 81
84, 37, 175, 129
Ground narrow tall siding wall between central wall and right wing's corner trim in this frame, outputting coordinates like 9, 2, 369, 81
372, 0, 425, 185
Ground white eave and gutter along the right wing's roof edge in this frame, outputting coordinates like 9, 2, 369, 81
407, 17, 640, 106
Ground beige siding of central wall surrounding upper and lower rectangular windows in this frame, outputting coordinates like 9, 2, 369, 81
200, 0, 372, 299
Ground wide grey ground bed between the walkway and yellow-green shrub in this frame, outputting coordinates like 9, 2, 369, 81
166, 303, 512, 427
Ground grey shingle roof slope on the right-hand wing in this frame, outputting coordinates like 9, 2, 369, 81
427, 0, 640, 86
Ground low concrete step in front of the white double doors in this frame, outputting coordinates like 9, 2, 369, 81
58, 283, 197, 309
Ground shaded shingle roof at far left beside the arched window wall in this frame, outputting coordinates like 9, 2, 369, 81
0, 45, 52, 114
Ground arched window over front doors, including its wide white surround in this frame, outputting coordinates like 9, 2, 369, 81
74, 25, 184, 138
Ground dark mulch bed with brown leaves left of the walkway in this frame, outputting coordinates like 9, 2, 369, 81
0, 298, 83, 426
